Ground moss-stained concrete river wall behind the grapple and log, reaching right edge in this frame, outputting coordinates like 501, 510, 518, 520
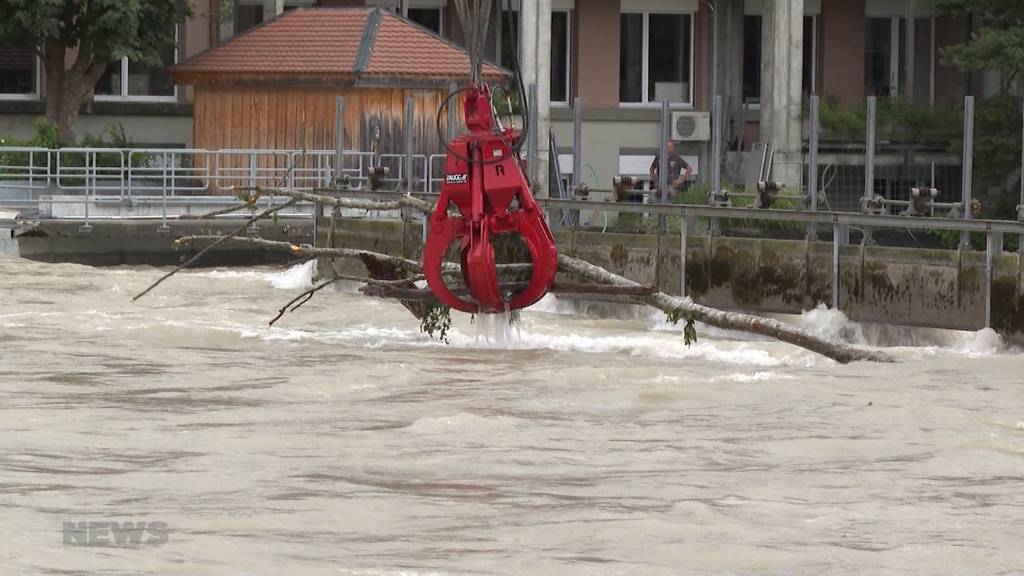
309, 219, 1024, 340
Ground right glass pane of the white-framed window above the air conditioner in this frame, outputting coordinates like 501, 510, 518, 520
647, 14, 690, 102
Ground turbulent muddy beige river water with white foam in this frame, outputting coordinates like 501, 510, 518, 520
0, 258, 1024, 576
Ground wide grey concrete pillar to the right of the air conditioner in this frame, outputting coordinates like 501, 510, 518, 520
761, 0, 804, 190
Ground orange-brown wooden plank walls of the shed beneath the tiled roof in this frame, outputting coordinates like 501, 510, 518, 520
193, 85, 458, 191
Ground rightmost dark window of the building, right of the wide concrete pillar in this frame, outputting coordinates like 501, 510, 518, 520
864, 17, 935, 104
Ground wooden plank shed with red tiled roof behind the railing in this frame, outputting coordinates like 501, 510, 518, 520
172, 7, 510, 161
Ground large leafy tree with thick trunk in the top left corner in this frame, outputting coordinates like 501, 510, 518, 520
0, 0, 191, 138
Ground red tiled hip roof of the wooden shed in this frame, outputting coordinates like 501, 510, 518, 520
177, 8, 509, 84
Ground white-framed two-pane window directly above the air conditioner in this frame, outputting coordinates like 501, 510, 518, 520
618, 12, 693, 104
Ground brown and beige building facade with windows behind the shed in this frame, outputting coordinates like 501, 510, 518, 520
0, 0, 1000, 188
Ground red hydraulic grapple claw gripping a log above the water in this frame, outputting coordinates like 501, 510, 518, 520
423, 84, 558, 314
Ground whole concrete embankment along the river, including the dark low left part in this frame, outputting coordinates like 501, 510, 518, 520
8, 217, 1024, 340
